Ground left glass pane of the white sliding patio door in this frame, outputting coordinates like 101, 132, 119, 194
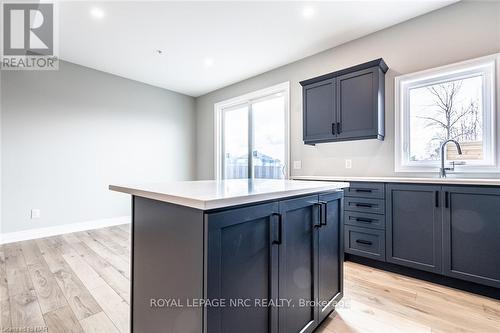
223, 105, 248, 179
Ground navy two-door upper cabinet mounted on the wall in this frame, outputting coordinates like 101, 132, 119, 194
300, 59, 388, 144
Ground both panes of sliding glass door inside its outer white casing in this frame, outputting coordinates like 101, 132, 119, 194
220, 93, 287, 179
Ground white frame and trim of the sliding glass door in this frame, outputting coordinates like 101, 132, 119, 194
214, 81, 290, 181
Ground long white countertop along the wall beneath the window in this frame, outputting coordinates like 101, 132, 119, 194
292, 176, 500, 186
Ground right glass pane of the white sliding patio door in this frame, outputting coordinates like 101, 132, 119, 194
252, 94, 285, 179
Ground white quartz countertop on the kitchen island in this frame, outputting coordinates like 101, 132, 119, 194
109, 179, 349, 210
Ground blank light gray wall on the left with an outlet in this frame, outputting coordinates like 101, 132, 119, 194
1, 62, 196, 233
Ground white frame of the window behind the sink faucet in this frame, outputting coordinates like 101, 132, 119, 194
394, 53, 500, 173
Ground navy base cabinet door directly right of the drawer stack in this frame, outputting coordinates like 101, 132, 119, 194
386, 184, 442, 273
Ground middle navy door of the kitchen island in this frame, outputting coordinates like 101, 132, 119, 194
279, 195, 321, 333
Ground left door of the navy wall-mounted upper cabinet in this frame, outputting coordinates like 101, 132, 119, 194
302, 79, 336, 143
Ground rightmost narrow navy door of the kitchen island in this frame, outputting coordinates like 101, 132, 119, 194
318, 192, 344, 322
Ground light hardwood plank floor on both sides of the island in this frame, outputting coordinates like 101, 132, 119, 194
0, 225, 500, 333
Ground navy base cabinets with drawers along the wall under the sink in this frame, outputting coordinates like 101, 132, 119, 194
344, 182, 500, 289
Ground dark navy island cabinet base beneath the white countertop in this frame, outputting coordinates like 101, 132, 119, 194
131, 191, 343, 333
